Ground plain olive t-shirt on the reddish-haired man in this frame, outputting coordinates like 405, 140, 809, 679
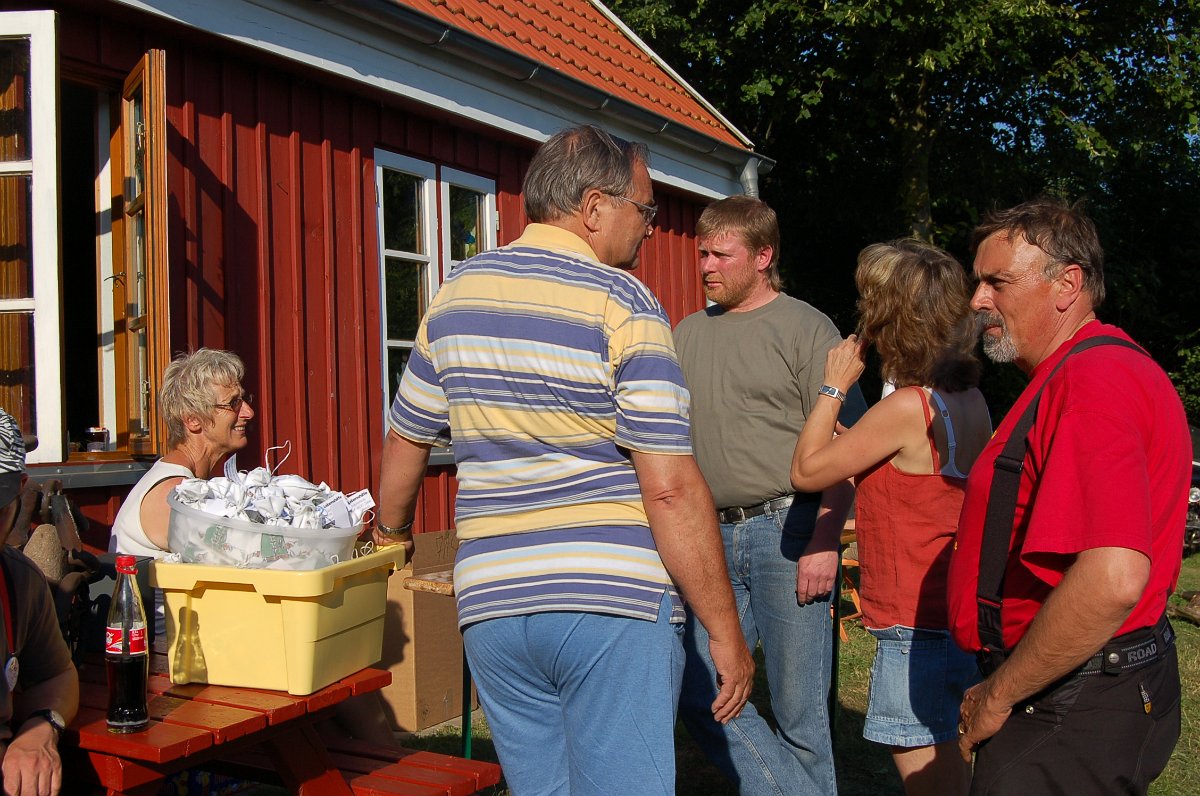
674, 294, 865, 508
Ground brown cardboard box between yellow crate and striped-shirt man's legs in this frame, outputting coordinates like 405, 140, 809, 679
380, 531, 475, 732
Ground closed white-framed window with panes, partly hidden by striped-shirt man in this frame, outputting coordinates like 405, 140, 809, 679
374, 150, 498, 422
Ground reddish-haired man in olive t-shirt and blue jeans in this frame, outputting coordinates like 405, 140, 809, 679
674, 196, 865, 796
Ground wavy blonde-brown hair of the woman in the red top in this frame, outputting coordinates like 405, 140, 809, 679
854, 239, 979, 393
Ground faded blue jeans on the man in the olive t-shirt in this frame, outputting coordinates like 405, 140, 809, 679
679, 501, 838, 796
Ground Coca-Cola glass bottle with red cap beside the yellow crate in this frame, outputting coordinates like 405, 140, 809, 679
104, 556, 150, 732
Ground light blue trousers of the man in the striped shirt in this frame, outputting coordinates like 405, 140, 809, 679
463, 594, 683, 796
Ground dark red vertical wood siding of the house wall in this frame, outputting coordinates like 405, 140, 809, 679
51, 6, 704, 531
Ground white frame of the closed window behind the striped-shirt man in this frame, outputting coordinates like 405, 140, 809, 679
374, 149, 499, 430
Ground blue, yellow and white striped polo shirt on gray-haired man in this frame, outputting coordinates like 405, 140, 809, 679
390, 223, 691, 627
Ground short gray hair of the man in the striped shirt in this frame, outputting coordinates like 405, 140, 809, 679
522, 125, 650, 222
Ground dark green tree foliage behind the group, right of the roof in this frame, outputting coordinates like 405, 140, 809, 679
610, 0, 1200, 420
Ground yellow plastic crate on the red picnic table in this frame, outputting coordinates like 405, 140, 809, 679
150, 545, 404, 695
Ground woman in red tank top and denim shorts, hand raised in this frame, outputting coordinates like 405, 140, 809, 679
792, 240, 991, 796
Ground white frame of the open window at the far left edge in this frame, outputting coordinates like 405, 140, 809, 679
0, 11, 66, 463
